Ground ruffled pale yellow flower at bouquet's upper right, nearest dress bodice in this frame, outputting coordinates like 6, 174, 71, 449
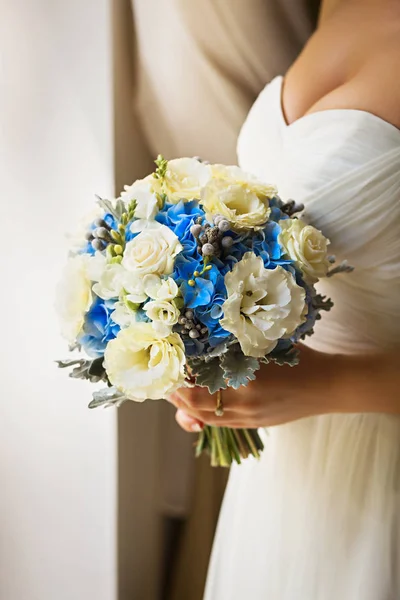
201, 165, 277, 230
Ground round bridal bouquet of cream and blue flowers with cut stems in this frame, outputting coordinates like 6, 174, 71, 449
57, 157, 340, 465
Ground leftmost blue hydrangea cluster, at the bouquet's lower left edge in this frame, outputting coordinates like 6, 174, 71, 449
78, 297, 120, 358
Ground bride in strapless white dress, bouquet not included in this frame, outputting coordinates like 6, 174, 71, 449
169, 0, 400, 600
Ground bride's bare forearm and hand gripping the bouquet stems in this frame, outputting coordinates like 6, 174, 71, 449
171, 347, 400, 431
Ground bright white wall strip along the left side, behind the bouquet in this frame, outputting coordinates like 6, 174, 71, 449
0, 0, 116, 600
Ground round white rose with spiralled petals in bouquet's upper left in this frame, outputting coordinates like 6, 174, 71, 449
122, 221, 182, 276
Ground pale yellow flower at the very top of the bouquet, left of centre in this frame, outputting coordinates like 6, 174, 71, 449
153, 158, 211, 204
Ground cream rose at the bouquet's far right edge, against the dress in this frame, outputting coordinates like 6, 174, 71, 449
278, 219, 330, 283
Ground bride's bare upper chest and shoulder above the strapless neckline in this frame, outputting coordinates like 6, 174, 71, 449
283, 9, 400, 129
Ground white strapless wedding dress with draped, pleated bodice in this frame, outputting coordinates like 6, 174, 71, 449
205, 77, 400, 600
